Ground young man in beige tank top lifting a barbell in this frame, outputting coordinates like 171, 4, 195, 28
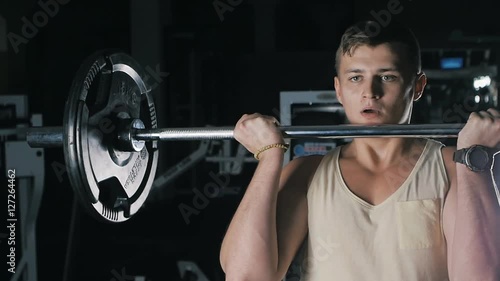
220, 22, 500, 281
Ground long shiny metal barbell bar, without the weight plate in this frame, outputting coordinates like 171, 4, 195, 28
26, 119, 464, 151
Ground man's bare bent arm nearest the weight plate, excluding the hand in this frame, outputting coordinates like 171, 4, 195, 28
220, 153, 321, 281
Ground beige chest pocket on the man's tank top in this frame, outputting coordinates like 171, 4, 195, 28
396, 198, 443, 250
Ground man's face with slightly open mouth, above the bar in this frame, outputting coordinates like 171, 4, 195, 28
335, 44, 425, 125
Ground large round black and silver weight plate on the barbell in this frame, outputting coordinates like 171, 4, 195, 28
63, 51, 158, 222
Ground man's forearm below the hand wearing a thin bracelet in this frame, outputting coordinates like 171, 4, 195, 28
220, 150, 283, 280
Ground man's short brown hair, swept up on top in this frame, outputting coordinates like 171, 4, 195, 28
335, 21, 422, 74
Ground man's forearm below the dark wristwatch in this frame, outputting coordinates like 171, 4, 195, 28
449, 164, 500, 281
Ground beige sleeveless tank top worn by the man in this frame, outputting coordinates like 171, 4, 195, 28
301, 140, 449, 281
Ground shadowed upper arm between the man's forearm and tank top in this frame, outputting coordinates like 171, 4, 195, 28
276, 156, 321, 277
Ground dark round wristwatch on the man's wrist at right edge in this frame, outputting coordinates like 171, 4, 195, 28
453, 145, 496, 172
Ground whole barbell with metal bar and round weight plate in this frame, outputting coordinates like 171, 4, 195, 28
20, 51, 464, 222
